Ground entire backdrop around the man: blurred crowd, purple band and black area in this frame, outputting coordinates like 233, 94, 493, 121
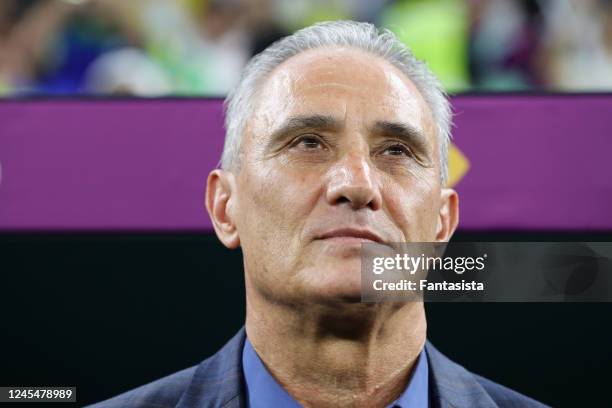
0, 0, 612, 407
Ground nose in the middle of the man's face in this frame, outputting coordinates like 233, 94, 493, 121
326, 152, 382, 211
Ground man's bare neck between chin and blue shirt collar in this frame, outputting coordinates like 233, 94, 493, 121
246, 293, 427, 407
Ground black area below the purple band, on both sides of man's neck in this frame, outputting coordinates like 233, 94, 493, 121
0, 232, 612, 407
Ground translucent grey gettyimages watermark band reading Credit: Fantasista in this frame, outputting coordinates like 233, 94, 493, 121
361, 242, 612, 302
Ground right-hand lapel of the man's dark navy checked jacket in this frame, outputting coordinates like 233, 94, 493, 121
425, 341, 498, 408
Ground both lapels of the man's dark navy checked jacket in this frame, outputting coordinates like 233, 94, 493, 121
176, 327, 498, 408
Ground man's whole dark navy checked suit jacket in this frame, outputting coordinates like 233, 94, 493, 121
90, 328, 545, 408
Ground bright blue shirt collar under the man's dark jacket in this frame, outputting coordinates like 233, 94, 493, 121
242, 338, 429, 408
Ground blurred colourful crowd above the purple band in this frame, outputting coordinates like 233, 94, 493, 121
0, 0, 612, 97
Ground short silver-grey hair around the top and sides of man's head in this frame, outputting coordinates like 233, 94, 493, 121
221, 21, 452, 185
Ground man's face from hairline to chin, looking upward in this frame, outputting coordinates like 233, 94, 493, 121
215, 48, 454, 303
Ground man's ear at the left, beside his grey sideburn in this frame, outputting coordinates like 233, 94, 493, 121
205, 169, 240, 249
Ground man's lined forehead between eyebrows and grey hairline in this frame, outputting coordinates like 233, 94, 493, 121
252, 47, 433, 138
